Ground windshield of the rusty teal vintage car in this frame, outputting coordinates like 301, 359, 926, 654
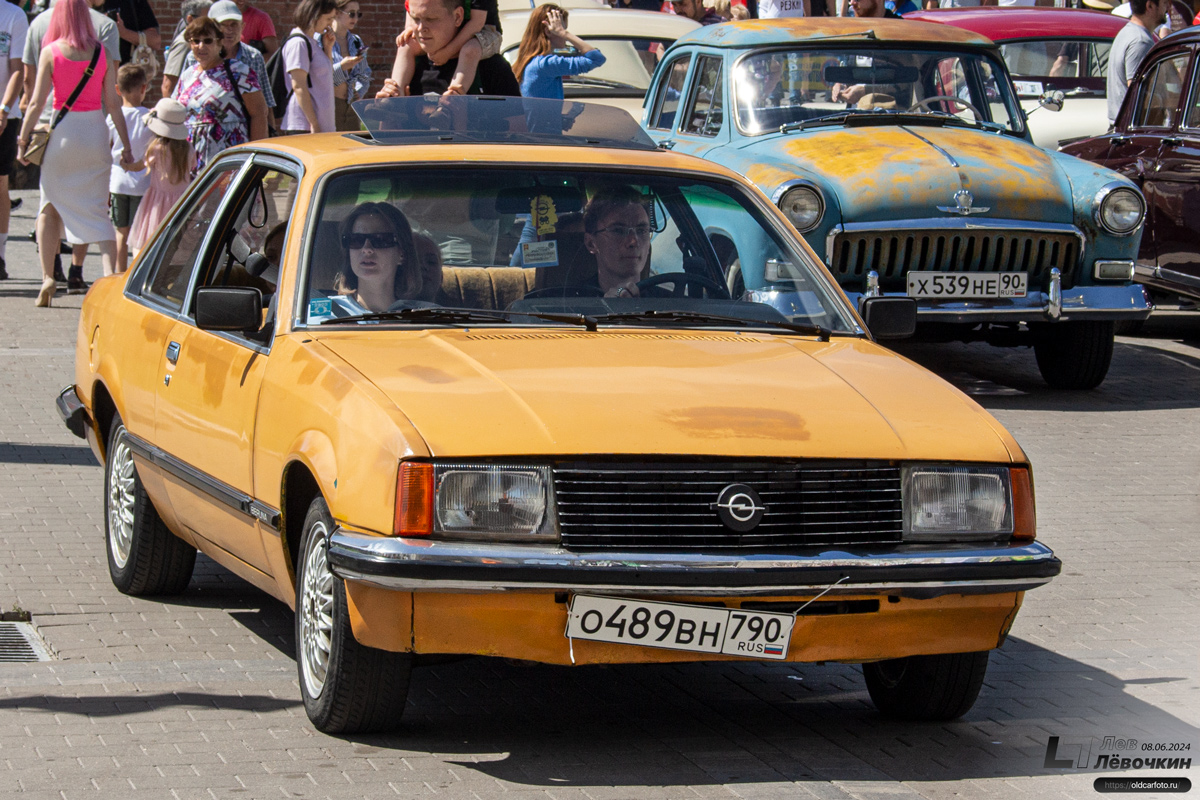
733, 47, 1024, 134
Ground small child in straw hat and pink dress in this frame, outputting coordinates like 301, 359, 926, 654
126, 97, 196, 249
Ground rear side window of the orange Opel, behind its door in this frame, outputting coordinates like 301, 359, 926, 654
143, 162, 241, 309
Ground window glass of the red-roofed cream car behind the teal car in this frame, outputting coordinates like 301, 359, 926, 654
1000, 38, 1112, 98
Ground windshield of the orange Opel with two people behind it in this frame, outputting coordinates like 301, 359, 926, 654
300, 166, 857, 333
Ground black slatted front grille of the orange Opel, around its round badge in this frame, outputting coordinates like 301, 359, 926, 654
554, 461, 902, 551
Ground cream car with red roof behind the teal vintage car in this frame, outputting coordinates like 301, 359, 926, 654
905, 6, 1129, 150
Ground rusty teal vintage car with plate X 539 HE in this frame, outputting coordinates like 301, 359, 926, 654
642, 18, 1151, 389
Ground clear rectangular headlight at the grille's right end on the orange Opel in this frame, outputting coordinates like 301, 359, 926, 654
904, 464, 1013, 542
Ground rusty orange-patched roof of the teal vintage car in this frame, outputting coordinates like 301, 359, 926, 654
676, 17, 995, 48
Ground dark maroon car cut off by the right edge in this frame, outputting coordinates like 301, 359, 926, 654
1062, 28, 1200, 299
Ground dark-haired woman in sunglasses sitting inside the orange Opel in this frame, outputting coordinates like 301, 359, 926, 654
332, 203, 431, 317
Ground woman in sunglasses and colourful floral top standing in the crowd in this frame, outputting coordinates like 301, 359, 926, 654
175, 17, 266, 175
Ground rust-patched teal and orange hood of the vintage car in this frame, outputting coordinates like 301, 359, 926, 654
743, 126, 1073, 223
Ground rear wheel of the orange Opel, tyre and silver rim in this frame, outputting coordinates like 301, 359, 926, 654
104, 416, 196, 596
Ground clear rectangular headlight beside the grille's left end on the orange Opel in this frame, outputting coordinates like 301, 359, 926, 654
433, 464, 558, 541
